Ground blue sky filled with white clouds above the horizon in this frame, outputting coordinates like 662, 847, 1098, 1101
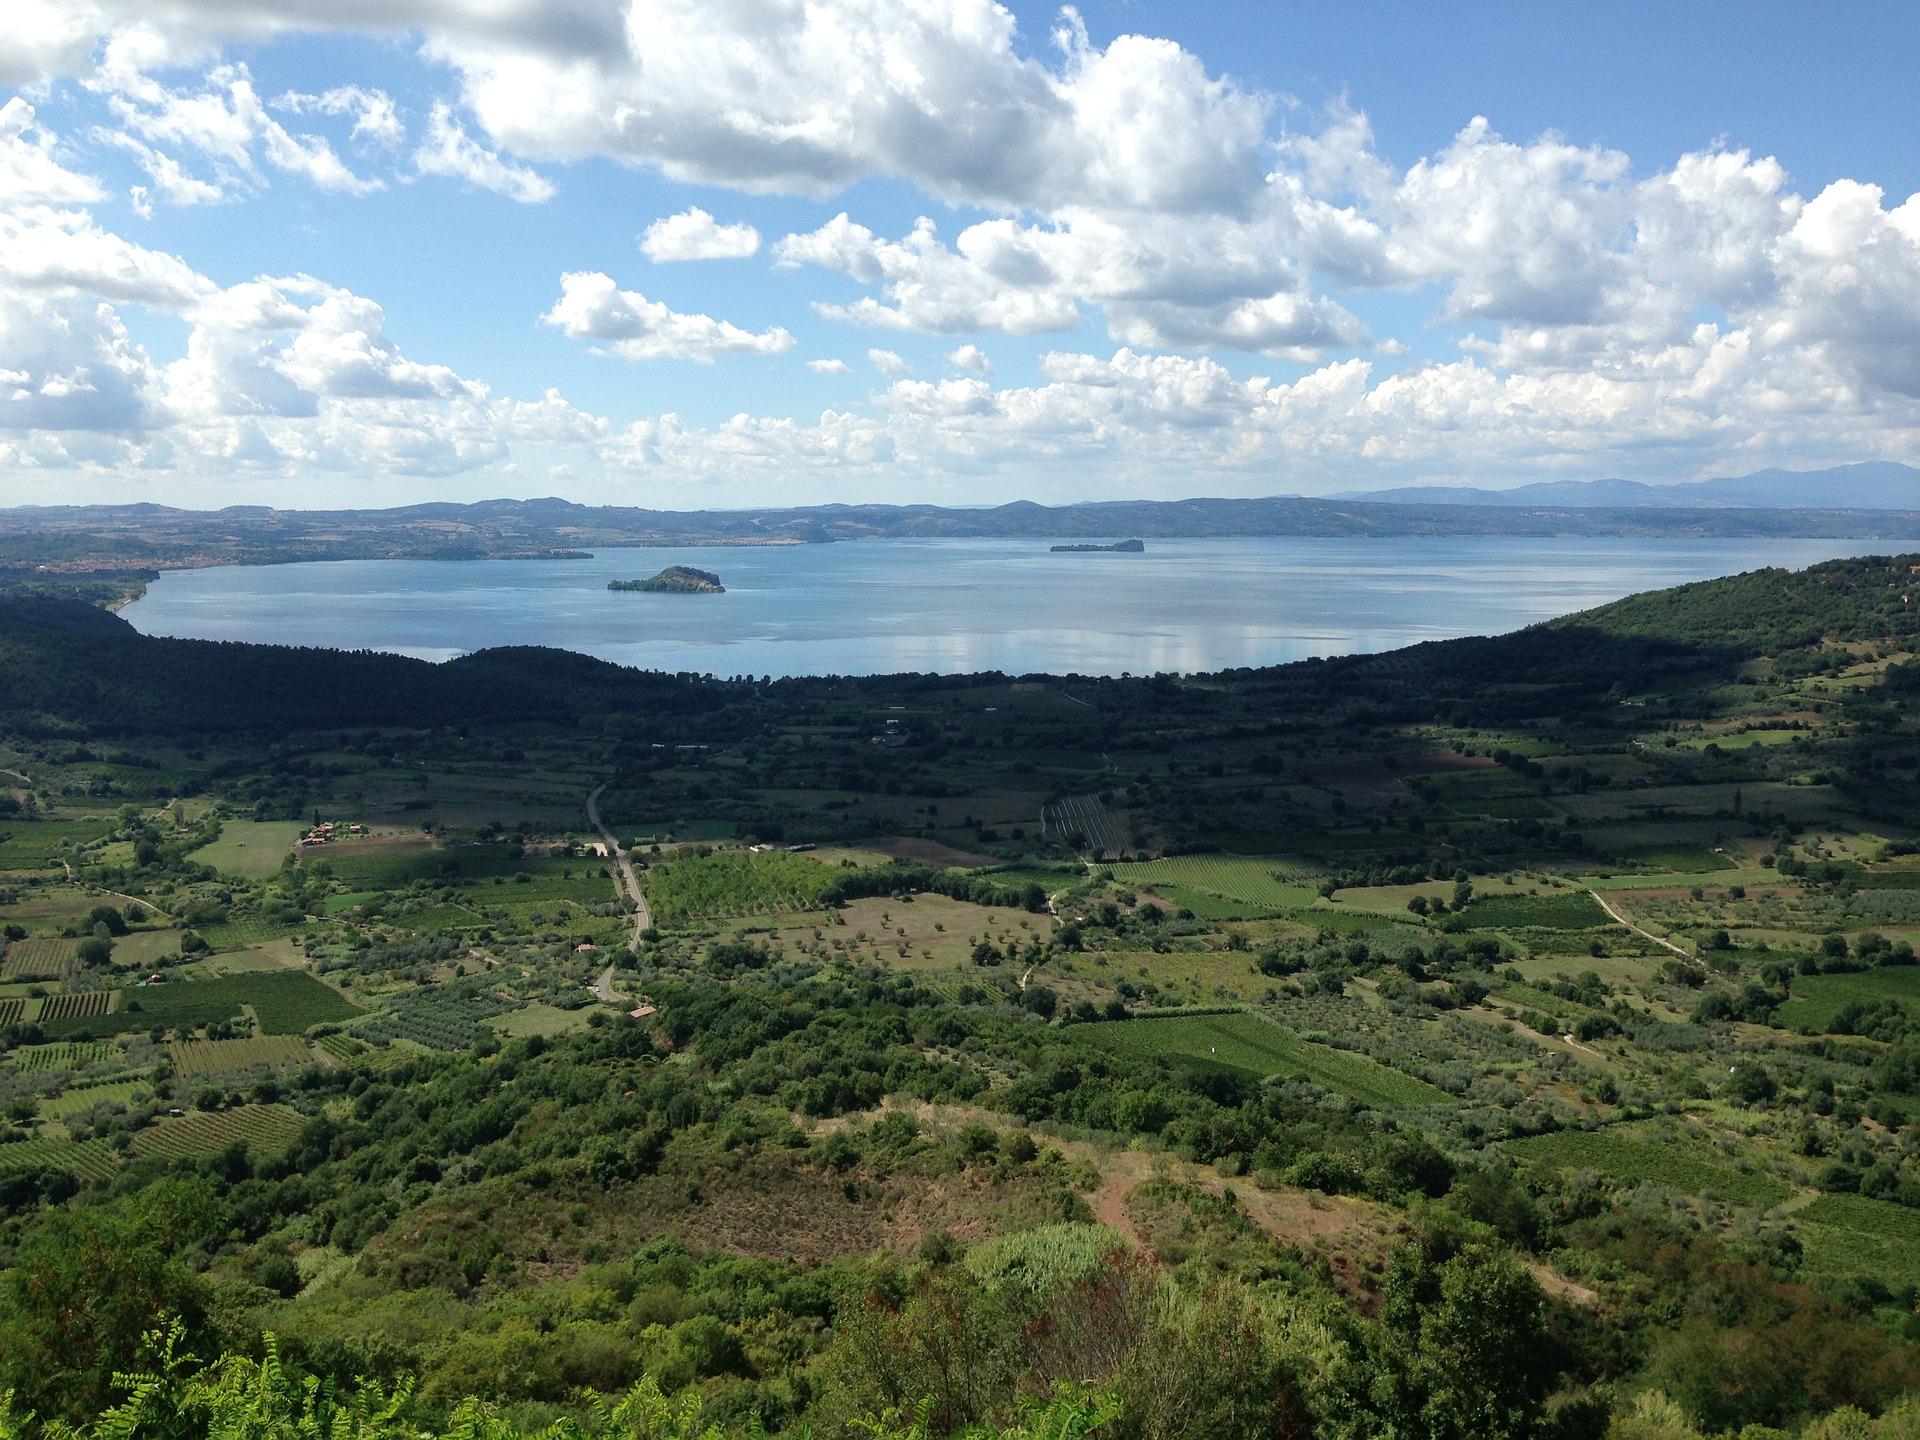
0, 0, 1920, 509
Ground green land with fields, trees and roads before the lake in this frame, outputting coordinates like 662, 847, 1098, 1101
0, 555, 1920, 1440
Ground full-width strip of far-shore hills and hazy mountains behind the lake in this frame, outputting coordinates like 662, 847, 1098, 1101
0, 463, 1920, 584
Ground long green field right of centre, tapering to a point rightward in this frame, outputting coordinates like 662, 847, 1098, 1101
1073, 1010, 1455, 1110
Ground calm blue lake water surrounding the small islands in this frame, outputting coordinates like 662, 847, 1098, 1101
123, 538, 1884, 676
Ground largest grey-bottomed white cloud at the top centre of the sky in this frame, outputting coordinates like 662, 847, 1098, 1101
430, 0, 1267, 211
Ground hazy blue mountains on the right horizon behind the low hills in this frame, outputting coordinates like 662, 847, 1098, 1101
1334, 461, 1920, 511
